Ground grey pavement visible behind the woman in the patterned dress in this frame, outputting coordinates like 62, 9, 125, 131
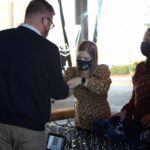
52, 76, 132, 112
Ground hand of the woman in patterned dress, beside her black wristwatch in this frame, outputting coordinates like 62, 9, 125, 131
67, 77, 81, 89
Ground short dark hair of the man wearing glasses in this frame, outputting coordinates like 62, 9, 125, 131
25, 0, 55, 18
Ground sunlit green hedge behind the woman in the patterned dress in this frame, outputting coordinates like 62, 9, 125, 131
110, 62, 138, 75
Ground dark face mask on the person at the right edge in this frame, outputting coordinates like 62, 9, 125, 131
141, 42, 150, 57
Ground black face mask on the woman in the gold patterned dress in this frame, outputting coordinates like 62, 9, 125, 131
77, 59, 91, 71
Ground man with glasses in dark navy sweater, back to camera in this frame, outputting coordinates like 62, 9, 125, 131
0, 0, 69, 150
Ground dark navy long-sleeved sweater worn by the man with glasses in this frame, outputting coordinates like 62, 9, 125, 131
0, 26, 69, 130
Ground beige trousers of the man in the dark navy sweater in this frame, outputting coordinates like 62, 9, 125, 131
0, 123, 46, 150
